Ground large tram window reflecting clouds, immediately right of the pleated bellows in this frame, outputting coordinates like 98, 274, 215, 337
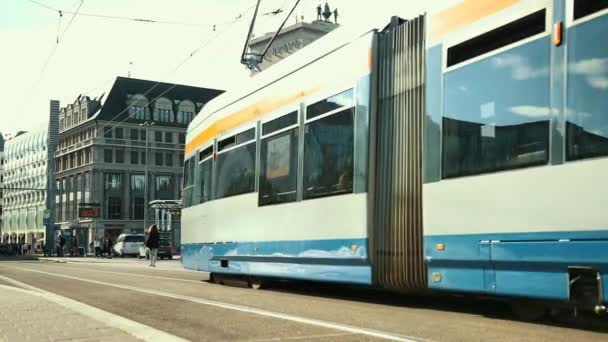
442, 37, 553, 178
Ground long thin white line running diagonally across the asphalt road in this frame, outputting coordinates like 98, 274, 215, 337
16, 267, 424, 342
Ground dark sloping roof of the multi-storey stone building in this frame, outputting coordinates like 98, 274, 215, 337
96, 77, 224, 126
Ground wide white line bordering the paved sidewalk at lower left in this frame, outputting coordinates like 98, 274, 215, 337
0, 275, 188, 342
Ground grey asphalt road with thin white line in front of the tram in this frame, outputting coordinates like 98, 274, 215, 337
0, 260, 608, 342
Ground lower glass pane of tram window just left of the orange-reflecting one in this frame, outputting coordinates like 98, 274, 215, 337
215, 143, 255, 199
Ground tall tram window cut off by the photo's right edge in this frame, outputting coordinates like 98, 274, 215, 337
566, 14, 608, 160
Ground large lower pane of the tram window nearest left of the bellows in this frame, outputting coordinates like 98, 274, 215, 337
304, 108, 354, 199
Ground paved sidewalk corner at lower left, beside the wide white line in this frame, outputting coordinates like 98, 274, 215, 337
0, 286, 140, 342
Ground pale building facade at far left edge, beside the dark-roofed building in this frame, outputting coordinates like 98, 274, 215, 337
2, 127, 48, 244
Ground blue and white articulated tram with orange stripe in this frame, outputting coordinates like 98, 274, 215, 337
182, 0, 608, 311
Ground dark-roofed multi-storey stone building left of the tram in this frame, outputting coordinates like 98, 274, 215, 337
55, 77, 221, 245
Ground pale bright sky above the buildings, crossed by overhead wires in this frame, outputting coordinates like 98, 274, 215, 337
0, 0, 436, 134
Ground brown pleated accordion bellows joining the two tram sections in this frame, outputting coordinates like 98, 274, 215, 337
370, 16, 427, 290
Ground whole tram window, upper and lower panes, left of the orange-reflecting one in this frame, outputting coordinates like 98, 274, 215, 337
215, 128, 256, 199
